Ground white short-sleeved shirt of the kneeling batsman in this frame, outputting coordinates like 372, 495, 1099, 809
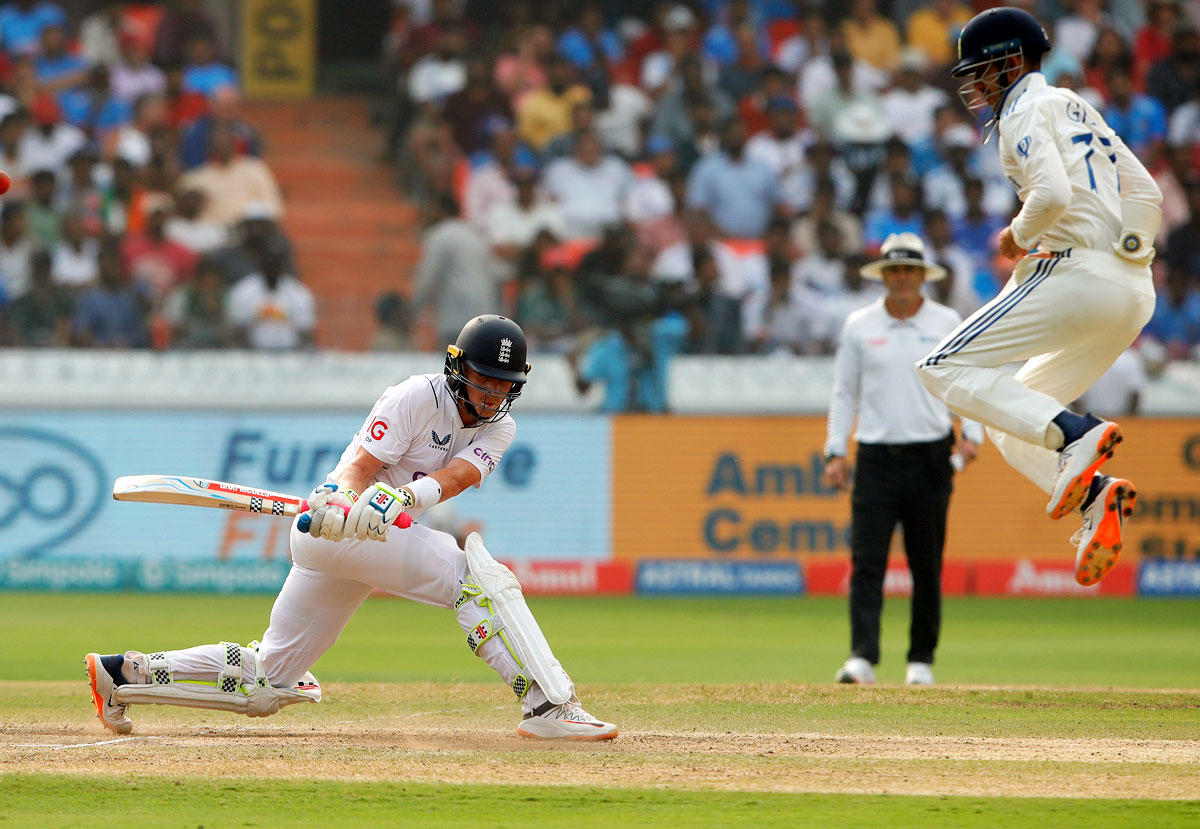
325, 374, 517, 517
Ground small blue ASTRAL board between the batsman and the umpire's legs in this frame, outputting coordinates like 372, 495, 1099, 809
634, 559, 804, 594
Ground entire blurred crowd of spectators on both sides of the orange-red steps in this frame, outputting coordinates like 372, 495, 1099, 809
0, 0, 1200, 383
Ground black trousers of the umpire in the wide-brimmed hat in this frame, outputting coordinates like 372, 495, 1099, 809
850, 435, 954, 665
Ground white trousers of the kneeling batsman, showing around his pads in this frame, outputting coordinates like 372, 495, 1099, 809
156, 522, 546, 710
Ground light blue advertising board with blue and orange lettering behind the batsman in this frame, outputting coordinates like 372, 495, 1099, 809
0, 412, 612, 563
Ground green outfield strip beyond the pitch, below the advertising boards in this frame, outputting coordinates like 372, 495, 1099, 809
7, 593, 1200, 689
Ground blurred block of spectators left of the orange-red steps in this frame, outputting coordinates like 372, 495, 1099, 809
0, 0, 314, 348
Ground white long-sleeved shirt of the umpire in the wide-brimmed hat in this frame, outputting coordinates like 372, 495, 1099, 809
824, 298, 983, 457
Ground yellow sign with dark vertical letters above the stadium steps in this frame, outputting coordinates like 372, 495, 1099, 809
241, 0, 317, 98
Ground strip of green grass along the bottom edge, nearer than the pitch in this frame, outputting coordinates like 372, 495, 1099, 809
7, 775, 1200, 829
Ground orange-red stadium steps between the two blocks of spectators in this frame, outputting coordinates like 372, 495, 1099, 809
236, 97, 419, 349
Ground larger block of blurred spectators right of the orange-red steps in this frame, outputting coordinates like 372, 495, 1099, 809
388, 0, 1200, 381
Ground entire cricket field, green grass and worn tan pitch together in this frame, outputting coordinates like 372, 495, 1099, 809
0, 594, 1200, 828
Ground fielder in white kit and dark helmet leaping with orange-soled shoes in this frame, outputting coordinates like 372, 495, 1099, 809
917, 8, 1163, 585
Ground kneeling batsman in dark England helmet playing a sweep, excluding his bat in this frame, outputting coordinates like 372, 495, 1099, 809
84, 314, 617, 740
